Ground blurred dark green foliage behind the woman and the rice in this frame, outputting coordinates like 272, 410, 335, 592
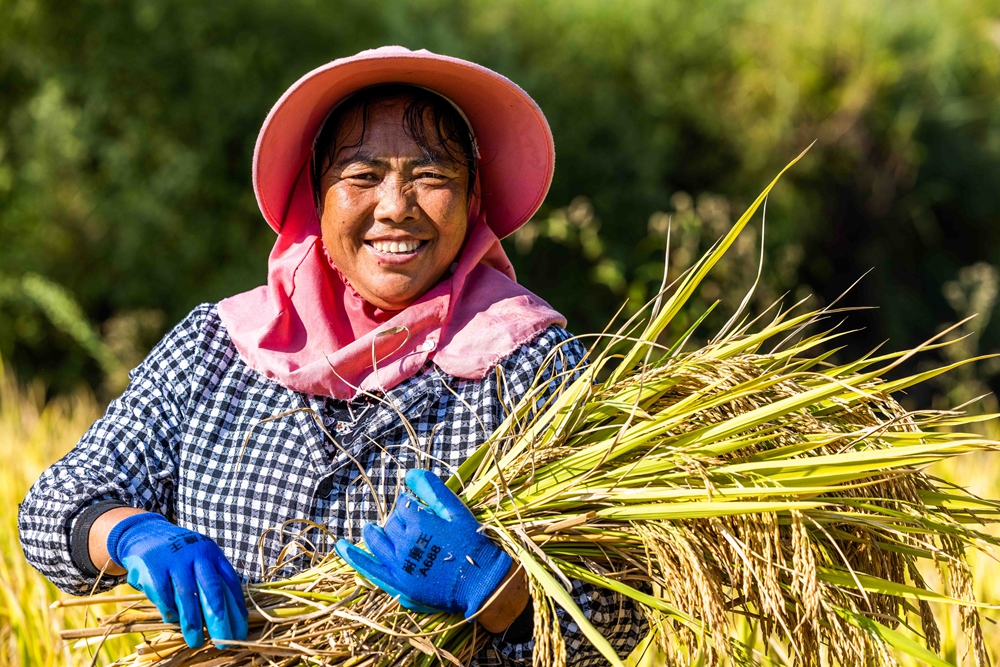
0, 0, 1000, 402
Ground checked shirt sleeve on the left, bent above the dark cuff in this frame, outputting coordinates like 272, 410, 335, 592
18, 304, 214, 595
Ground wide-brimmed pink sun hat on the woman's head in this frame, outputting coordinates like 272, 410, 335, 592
253, 46, 556, 238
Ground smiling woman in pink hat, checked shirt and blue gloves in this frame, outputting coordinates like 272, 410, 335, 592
19, 47, 639, 665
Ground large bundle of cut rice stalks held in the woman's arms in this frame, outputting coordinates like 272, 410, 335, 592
65, 151, 1000, 667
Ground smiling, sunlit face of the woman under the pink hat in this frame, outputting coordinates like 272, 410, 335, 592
320, 103, 469, 310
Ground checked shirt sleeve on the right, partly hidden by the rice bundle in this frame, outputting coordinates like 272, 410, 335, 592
476, 326, 646, 667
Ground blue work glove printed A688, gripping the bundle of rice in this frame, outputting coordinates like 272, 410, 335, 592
336, 470, 511, 618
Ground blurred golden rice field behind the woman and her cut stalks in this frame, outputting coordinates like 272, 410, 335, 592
0, 352, 1000, 667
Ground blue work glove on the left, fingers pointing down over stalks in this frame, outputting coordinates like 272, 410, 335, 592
108, 513, 247, 648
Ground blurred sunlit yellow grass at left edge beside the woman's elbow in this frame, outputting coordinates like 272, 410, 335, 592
0, 364, 133, 667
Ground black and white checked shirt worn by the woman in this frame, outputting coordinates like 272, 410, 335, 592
19, 304, 645, 666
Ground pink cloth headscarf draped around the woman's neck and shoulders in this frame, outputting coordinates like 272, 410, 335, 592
219, 52, 566, 399
